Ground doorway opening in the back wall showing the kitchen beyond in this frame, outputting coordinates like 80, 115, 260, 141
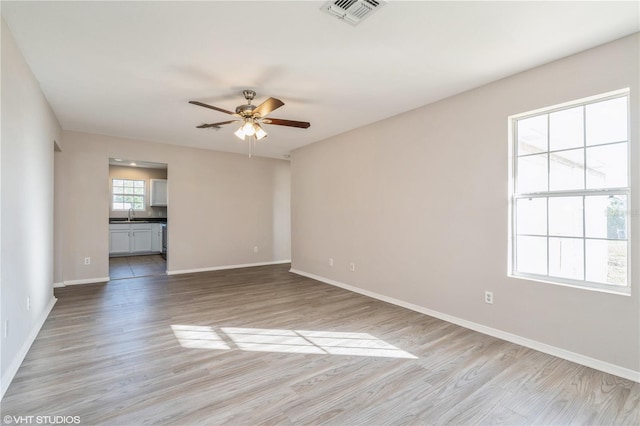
108, 158, 168, 279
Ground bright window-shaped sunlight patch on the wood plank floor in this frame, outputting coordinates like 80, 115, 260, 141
171, 325, 417, 359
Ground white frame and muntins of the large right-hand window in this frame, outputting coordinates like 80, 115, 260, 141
508, 88, 635, 295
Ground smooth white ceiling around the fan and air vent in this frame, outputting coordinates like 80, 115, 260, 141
1, 0, 640, 158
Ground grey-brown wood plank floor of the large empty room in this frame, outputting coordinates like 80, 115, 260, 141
1, 265, 640, 425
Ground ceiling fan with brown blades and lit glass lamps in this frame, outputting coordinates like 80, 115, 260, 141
189, 90, 311, 155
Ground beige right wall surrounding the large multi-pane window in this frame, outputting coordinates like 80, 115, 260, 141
291, 34, 640, 377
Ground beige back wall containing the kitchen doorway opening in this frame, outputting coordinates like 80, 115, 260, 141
56, 132, 290, 283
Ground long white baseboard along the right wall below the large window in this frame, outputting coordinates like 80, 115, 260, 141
290, 268, 640, 383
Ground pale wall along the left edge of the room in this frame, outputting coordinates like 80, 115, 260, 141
0, 20, 62, 394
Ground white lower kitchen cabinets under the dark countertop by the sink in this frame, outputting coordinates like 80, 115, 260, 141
109, 223, 162, 254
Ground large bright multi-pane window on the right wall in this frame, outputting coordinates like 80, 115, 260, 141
511, 91, 631, 292
